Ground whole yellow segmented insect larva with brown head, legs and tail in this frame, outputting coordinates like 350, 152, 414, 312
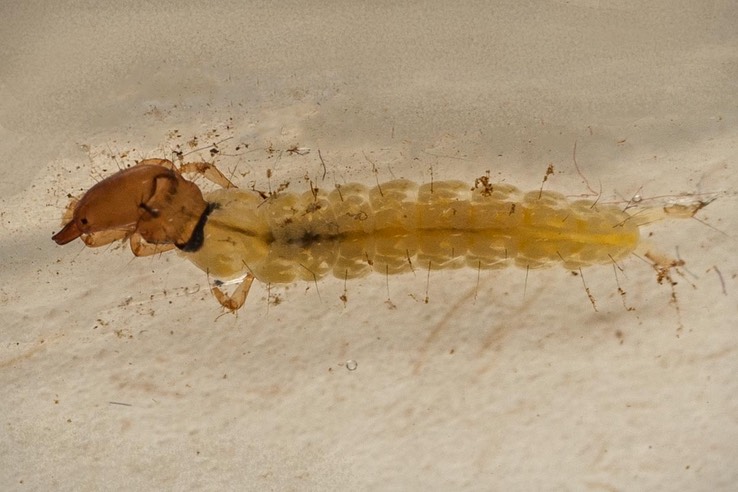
53, 159, 709, 310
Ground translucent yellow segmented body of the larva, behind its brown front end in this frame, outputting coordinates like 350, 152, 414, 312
183, 180, 639, 283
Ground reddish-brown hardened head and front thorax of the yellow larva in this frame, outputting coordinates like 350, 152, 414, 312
52, 161, 208, 250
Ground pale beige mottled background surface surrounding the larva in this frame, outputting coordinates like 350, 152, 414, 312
0, 0, 738, 490
